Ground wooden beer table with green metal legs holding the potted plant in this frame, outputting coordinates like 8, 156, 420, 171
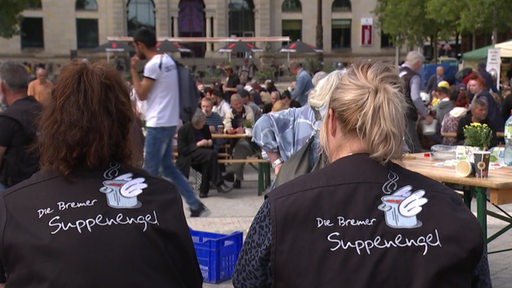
397, 153, 512, 253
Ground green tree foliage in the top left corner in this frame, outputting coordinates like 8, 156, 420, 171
0, 0, 41, 38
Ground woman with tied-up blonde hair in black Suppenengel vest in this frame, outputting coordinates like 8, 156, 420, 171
233, 63, 490, 288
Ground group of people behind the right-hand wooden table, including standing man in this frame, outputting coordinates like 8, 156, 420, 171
402, 51, 512, 152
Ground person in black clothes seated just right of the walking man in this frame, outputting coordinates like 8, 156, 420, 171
176, 109, 231, 198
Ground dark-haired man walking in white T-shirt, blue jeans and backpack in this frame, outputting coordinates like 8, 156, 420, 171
130, 28, 210, 217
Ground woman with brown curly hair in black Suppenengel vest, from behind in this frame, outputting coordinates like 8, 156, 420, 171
0, 62, 202, 287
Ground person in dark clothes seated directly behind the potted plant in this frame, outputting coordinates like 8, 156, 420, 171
457, 98, 498, 148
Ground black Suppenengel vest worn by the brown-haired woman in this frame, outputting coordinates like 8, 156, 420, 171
0, 165, 202, 288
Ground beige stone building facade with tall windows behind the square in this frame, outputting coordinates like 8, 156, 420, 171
0, 0, 395, 76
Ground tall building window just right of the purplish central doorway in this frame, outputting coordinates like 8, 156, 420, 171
229, 0, 254, 37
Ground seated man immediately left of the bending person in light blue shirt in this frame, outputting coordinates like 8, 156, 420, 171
224, 93, 257, 188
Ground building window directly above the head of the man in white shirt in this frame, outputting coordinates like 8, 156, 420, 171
126, 0, 155, 36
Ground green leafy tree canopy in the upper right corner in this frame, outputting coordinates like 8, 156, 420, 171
373, 0, 512, 58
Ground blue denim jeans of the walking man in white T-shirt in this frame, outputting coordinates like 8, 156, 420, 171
143, 126, 200, 209
